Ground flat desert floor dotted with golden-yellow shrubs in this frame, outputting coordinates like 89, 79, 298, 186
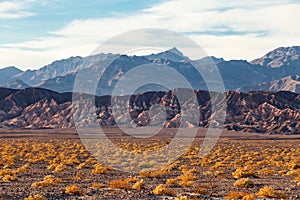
0, 128, 300, 200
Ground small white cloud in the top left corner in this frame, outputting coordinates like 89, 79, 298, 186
0, 1, 34, 19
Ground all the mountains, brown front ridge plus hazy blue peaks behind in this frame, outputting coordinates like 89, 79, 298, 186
0, 46, 300, 134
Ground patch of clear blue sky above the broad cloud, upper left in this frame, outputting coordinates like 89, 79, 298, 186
0, 0, 163, 44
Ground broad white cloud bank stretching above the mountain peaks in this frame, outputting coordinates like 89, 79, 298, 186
0, 0, 300, 67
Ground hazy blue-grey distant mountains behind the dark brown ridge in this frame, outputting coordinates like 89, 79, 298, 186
0, 46, 300, 96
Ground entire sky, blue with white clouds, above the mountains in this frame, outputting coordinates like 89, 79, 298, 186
0, 0, 300, 70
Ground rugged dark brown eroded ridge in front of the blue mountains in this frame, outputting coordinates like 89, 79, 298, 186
0, 88, 300, 134
